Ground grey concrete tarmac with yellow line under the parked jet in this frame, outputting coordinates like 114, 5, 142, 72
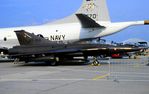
0, 60, 149, 94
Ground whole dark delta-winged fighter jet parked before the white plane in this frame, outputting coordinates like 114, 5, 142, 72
9, 30, 140, 65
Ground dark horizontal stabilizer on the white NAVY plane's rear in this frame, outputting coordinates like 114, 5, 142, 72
76, 14, 105, 28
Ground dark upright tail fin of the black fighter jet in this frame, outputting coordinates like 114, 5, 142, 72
14, 30, 50, 45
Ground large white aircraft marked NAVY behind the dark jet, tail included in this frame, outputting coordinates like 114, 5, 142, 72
0, 0, 149, 48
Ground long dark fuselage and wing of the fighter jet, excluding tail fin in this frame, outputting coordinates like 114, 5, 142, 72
9, 44, 140, 57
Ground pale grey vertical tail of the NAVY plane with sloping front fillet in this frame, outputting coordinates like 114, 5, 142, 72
50, 0, 110, 24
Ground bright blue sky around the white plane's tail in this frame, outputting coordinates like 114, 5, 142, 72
0, 0, 149, 42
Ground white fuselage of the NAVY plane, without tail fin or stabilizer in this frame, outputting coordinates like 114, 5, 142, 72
0, 21, 144, 48
